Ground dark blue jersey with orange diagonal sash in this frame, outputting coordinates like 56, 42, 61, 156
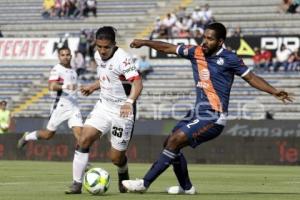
177, 45, 250, 113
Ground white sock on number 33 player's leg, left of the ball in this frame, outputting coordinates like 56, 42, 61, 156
73, 151, 89, 183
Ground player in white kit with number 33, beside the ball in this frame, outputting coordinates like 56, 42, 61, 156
65, 26, 143, 194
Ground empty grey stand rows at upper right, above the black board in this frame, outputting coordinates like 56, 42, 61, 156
190, 0, 300, 35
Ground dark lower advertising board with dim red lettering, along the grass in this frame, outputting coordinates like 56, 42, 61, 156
0, 134, 300, 165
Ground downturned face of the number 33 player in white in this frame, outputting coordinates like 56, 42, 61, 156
96, 39, 116, 60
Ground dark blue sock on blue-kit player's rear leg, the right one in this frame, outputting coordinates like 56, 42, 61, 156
172, 153, 192, 190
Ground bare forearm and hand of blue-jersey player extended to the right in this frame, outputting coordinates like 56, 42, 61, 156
243, 72, 293, 103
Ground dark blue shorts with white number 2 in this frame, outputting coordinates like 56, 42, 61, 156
172, 110, 224, 148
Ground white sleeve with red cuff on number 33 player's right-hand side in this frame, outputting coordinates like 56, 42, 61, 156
120, 56, 140, 81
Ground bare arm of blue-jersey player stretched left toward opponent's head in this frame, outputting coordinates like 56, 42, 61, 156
130, 39, 177, 54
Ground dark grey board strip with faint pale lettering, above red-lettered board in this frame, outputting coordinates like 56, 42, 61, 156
14, 118, 300, 138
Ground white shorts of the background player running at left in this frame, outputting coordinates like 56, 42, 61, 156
47, 103, 83, 131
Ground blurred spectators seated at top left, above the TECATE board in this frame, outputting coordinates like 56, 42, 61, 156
42, 0, 97, 19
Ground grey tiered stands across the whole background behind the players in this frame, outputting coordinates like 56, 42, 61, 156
0, 0, 300, 119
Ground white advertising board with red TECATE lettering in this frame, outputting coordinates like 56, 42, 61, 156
0, 38, 79, 60
